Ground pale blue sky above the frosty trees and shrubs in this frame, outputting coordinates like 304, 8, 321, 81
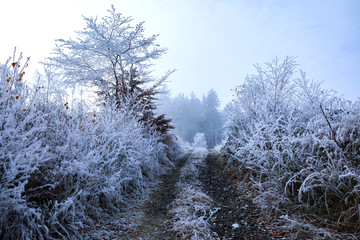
0, 0, 360, 107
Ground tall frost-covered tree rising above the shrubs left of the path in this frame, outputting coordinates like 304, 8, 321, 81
49, 6, 171, 132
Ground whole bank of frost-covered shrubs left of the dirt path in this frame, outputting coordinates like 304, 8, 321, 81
0, 51, 179, 239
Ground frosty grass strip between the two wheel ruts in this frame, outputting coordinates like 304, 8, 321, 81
169, 148, 216, 240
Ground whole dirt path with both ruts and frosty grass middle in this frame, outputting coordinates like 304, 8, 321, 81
87, 152, 280, 240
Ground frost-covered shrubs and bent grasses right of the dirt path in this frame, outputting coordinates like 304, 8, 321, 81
222, 58, 360, 234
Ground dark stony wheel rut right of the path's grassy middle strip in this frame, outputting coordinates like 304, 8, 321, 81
200, 153, 272, 240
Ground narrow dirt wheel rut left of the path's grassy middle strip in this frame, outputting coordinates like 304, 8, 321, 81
126, 154, 189, 240
